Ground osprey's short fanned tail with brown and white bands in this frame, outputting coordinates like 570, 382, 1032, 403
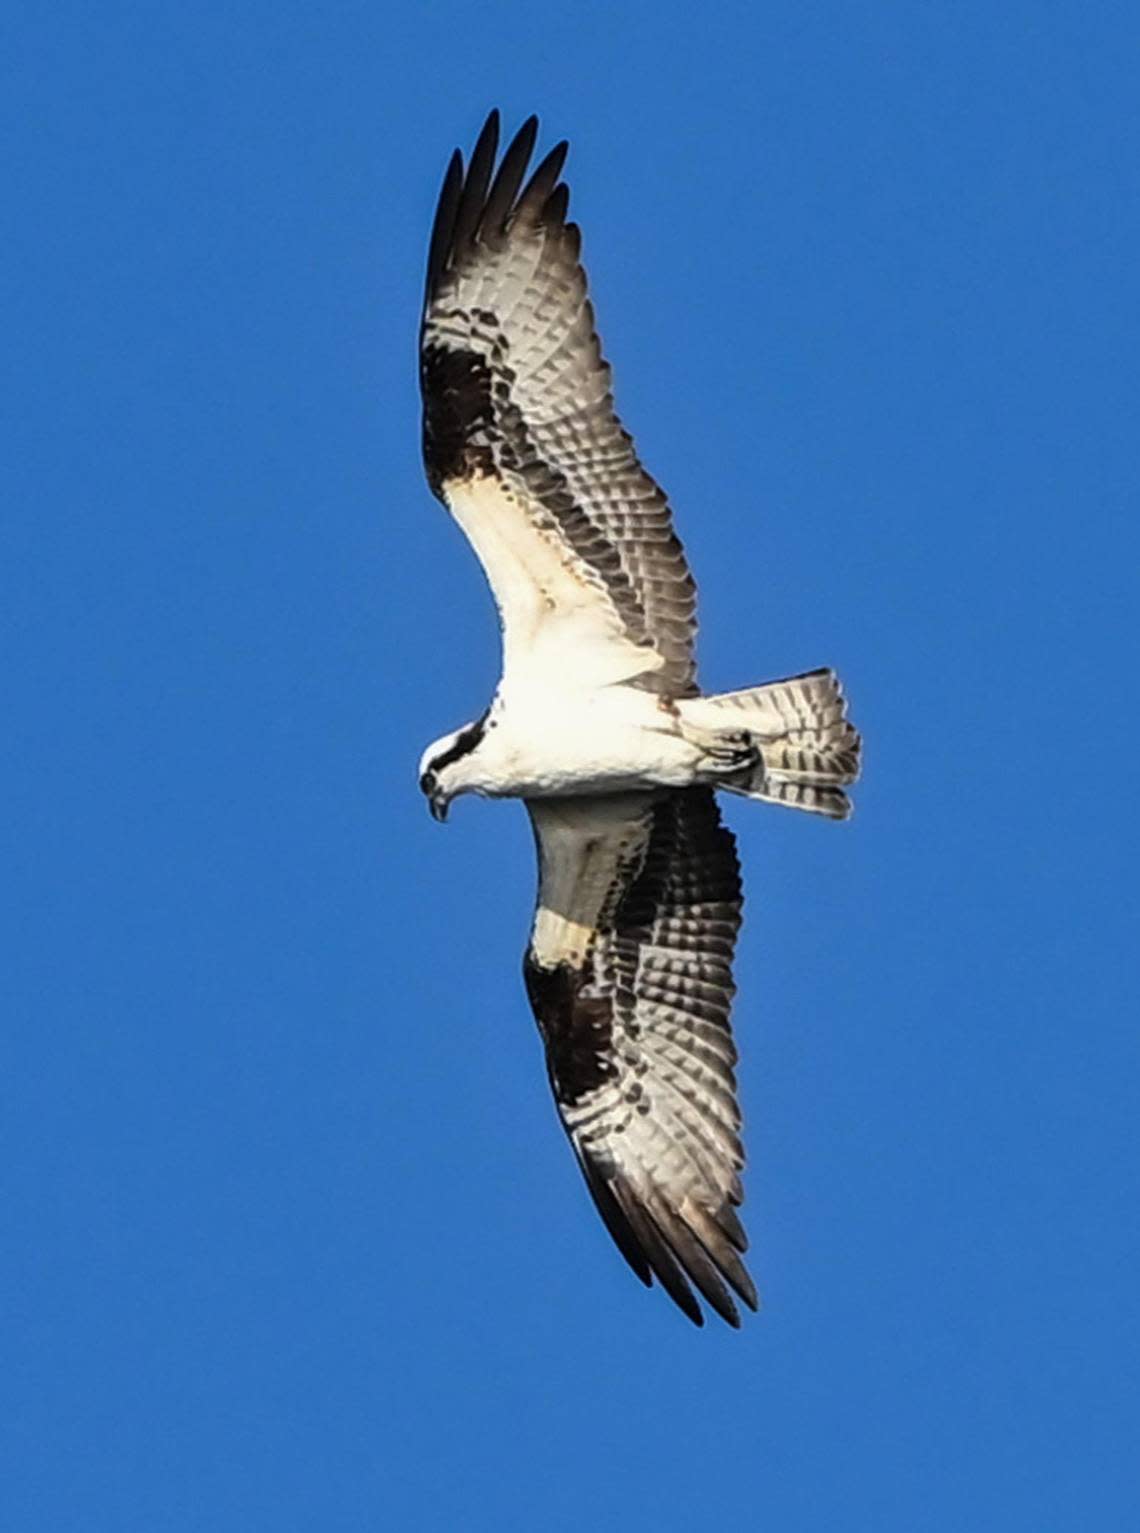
679, 670, 861, 820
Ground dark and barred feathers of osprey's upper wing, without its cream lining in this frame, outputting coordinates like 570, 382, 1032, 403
420, 112, 696, 696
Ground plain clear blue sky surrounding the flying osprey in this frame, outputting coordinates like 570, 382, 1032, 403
0, 0, 1140, 1533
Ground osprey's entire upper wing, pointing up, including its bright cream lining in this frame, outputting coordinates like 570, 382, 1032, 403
420, 112, 696, 696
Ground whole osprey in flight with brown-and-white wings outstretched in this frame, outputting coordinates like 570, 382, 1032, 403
420, 112, 860, 1326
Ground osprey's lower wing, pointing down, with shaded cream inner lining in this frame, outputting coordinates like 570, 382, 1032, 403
524, 788, 757, 1326
